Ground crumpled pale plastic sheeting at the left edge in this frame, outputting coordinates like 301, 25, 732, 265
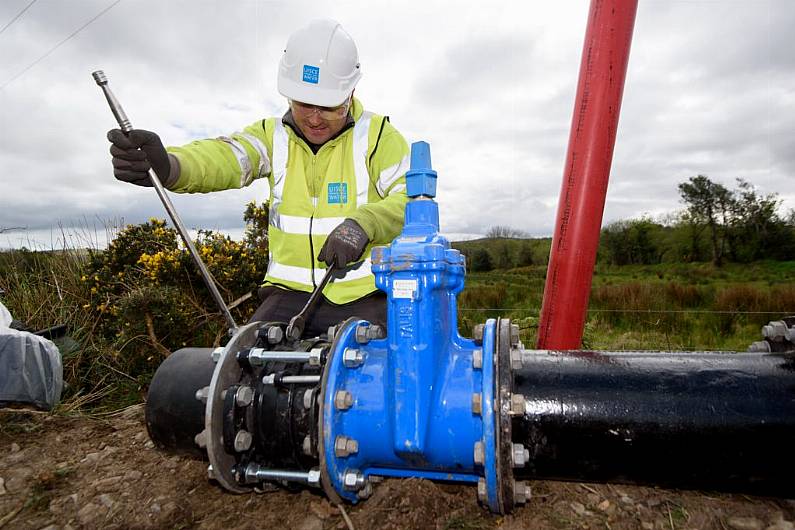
0, 303, 63, 410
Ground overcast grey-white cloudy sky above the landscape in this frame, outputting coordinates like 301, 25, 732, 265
0, 0, 795, 247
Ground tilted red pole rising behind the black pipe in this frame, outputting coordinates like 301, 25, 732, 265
537, 0, 638, 350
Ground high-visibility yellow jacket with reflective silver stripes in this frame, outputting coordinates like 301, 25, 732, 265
168, 98, 409, 304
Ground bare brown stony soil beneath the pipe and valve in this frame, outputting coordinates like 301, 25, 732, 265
0, 406, 795, 530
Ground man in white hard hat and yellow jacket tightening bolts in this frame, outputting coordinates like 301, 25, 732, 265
108, 19, 409, 336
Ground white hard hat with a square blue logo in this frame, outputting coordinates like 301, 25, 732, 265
277, 19, 362, 107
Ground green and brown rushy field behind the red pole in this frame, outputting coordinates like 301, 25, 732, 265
460, 261, 795, 351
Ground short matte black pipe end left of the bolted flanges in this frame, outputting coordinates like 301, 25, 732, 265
146, 348, 215, 458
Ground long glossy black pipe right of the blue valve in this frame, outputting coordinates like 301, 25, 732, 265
512, 351, 795, 497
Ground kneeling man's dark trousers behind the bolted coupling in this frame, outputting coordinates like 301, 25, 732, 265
249, 286, 386, 337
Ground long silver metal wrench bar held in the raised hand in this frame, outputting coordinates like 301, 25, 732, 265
91, 70, 237, 334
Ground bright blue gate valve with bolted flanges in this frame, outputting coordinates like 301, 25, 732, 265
319, 142, 500, 511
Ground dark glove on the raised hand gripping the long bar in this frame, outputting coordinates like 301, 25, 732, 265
108, 129, 179, 188
